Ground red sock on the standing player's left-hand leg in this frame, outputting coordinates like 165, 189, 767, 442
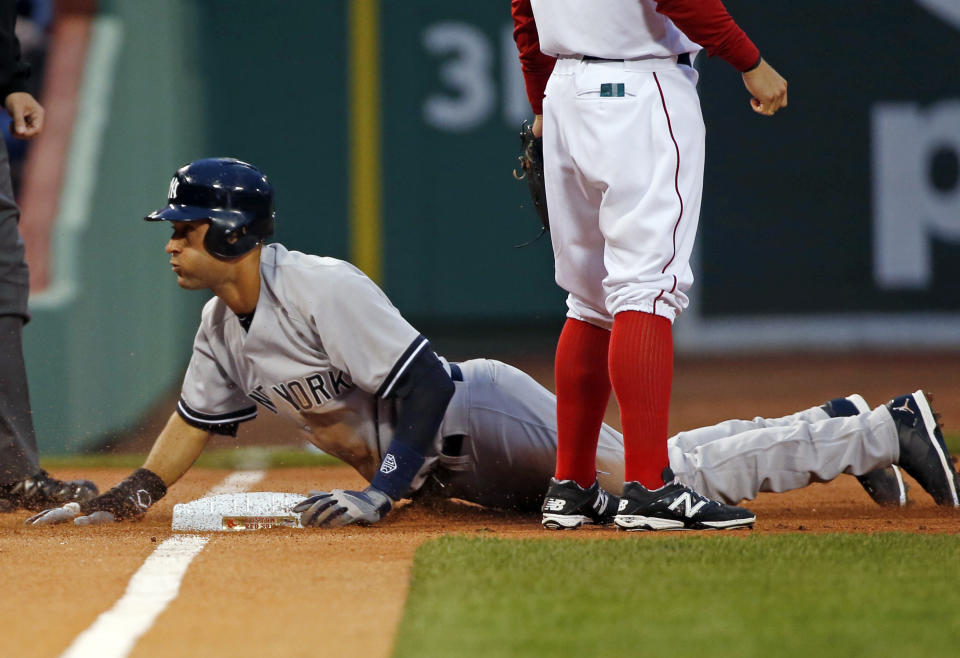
554, 318, 610, 487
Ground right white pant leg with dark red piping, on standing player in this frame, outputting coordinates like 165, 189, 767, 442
600, 62, 704, 320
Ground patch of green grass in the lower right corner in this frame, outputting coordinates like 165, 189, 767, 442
395, 533, 960, 658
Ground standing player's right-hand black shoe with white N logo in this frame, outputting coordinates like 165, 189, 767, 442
615, 467, 757, 530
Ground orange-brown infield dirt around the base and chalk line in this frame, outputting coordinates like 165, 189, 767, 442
0, 467, 960, 656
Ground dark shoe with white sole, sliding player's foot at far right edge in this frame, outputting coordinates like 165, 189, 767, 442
887, 391, 958, 507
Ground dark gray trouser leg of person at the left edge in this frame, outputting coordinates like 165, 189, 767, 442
0, 139, 40, 485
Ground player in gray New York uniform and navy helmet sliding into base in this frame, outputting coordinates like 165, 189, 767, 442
27, 158, 957, 528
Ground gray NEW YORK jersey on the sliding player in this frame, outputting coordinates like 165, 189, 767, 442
178, 244, 439, 488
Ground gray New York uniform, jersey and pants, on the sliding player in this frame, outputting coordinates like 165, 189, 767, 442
178, 244, 898, 511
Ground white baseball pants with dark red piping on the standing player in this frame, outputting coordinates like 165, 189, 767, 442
544, 58, 704, 326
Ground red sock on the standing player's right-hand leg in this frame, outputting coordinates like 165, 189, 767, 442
610, 311, 673, 489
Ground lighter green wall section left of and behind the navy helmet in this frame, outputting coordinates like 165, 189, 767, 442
24, 2, 206, 453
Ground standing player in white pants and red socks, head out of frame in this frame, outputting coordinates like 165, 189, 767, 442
511, 0, 787, 529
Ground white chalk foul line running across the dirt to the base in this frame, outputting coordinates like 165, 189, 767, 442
61, 471, 264, 658
